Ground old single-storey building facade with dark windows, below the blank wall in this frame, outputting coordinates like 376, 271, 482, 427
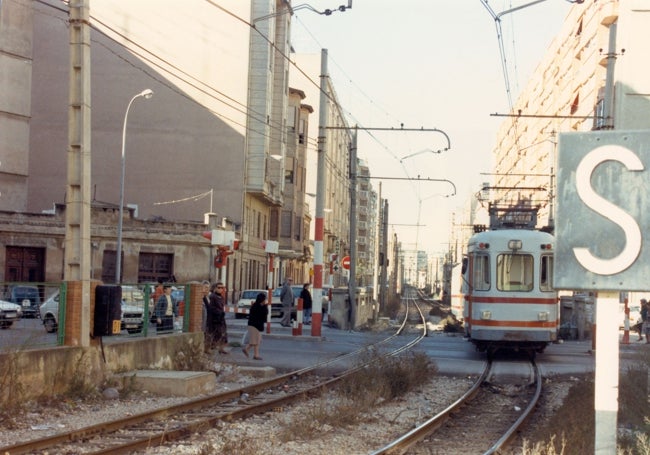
0, 205, 224, 283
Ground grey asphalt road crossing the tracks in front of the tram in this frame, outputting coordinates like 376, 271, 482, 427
5, 315, 650, 382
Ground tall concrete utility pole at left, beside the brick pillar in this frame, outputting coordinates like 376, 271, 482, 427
64, 0, 91, 347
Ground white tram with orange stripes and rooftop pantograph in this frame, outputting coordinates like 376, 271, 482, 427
461, 205, 560, 357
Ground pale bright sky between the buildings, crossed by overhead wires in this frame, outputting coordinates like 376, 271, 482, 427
291, 0, 571, 254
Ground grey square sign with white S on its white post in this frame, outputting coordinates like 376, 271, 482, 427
553, 131, 650, 454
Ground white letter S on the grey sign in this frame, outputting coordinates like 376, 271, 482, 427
573, 145, 643, 275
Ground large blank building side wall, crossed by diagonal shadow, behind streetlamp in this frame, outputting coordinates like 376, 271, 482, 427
27, 0, 250, 224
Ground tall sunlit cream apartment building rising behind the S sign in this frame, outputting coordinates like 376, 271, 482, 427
485, 0, 650, 226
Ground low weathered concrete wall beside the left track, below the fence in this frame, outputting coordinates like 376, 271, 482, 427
0, 332, 203, 402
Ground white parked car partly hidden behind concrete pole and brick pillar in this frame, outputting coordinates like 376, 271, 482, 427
40, 286, 144, 334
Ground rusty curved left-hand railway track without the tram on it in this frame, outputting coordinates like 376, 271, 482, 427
0, 296, 426, 455
